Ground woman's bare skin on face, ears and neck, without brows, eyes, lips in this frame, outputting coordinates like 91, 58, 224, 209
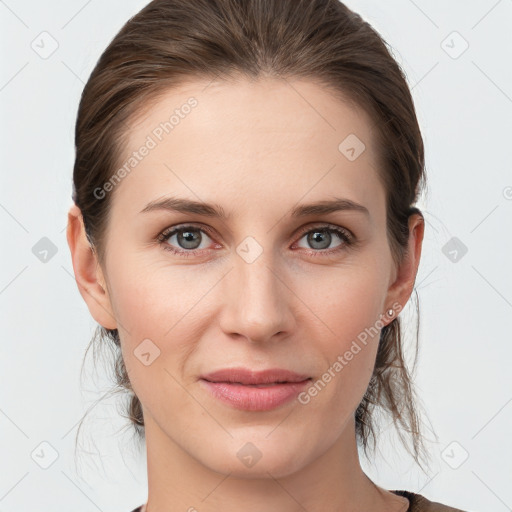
67, 78, 424, 512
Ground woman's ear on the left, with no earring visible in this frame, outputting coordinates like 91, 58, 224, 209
66, 204, 117, 329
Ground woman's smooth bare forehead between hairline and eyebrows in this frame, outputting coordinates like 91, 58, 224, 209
114, 78, 383, 222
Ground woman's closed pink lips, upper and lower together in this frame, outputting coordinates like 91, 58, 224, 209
200, 368, 311, 411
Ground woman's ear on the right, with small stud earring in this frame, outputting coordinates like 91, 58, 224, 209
384, 213, 425, 321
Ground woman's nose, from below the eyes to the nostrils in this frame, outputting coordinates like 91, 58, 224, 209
220, 251, 295, 343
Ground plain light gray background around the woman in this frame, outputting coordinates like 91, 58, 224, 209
0, 0, 512, 512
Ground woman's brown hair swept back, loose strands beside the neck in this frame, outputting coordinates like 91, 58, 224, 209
73, 0, 432, 472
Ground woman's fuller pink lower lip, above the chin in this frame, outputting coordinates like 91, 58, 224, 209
201, 379, 311, 411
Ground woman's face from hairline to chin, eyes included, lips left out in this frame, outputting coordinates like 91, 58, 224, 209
70, 79, 422, 478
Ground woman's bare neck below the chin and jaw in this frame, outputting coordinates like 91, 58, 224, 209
140, 416, 408, 512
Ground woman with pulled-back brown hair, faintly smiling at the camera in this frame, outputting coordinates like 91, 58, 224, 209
67, 0, 468, 512
